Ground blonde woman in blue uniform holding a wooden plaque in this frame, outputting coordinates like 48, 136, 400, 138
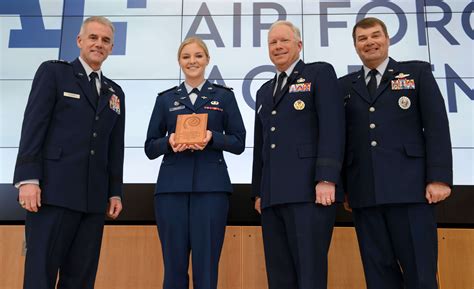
145, 37, 245, 289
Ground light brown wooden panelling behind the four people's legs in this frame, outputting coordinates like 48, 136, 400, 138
0, 226, 474, 289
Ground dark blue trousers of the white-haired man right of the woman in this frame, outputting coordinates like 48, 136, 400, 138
262, 203, 336, 289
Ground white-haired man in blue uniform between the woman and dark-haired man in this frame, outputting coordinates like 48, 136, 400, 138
252, 21, 344, 289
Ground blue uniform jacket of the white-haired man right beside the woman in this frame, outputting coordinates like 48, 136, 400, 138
252, 60, 345, 208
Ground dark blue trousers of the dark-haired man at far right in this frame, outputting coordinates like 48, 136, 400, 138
352, 203, 438, 289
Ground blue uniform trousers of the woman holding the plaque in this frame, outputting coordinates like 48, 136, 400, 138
155, 192, 229, 289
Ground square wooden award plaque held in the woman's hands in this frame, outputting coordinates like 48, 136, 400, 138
175, 113, 207, 144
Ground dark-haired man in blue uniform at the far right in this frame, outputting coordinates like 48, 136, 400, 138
340, 18, 452, 289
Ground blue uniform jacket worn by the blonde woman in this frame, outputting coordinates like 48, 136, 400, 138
145, 81, 246, 194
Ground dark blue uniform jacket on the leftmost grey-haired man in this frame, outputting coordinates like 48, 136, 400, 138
13, 59, 125, 213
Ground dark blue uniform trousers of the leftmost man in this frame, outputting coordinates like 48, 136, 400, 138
23, 205, 105, 289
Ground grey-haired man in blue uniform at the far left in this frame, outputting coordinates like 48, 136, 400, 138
14, 17, 125, 289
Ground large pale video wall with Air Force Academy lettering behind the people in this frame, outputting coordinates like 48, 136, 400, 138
0, 0, 474, 220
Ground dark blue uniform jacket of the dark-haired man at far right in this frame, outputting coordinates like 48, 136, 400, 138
340, 59, 453, 208
